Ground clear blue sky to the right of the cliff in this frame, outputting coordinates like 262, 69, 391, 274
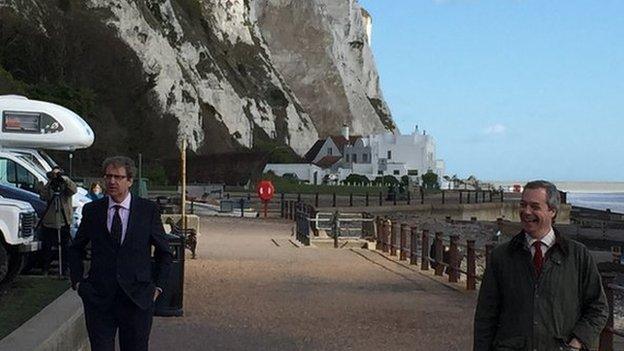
359, 0, 624, 181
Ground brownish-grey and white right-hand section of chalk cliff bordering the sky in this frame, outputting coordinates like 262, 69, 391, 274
253, 0, 395, 136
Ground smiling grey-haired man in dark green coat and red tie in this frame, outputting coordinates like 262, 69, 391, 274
474, 180, 609, 351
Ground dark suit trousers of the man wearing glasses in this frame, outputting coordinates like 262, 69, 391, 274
83, 288, 154, 351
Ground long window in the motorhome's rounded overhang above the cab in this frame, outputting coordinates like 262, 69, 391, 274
2, 111, 63, 134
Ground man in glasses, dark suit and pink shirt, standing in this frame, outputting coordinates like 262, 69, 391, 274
69, 156, 172, 351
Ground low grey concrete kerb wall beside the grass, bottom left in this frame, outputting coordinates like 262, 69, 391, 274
0, 290, 91, 351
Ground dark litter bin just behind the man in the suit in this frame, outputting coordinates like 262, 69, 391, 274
152, 234, 184, 317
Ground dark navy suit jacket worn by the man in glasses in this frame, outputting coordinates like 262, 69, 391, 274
68, 196, 173, 309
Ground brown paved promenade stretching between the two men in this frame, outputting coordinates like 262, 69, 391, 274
150, 218, 475, 351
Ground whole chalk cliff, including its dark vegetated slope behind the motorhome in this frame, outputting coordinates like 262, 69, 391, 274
0, 0, 394, 182
